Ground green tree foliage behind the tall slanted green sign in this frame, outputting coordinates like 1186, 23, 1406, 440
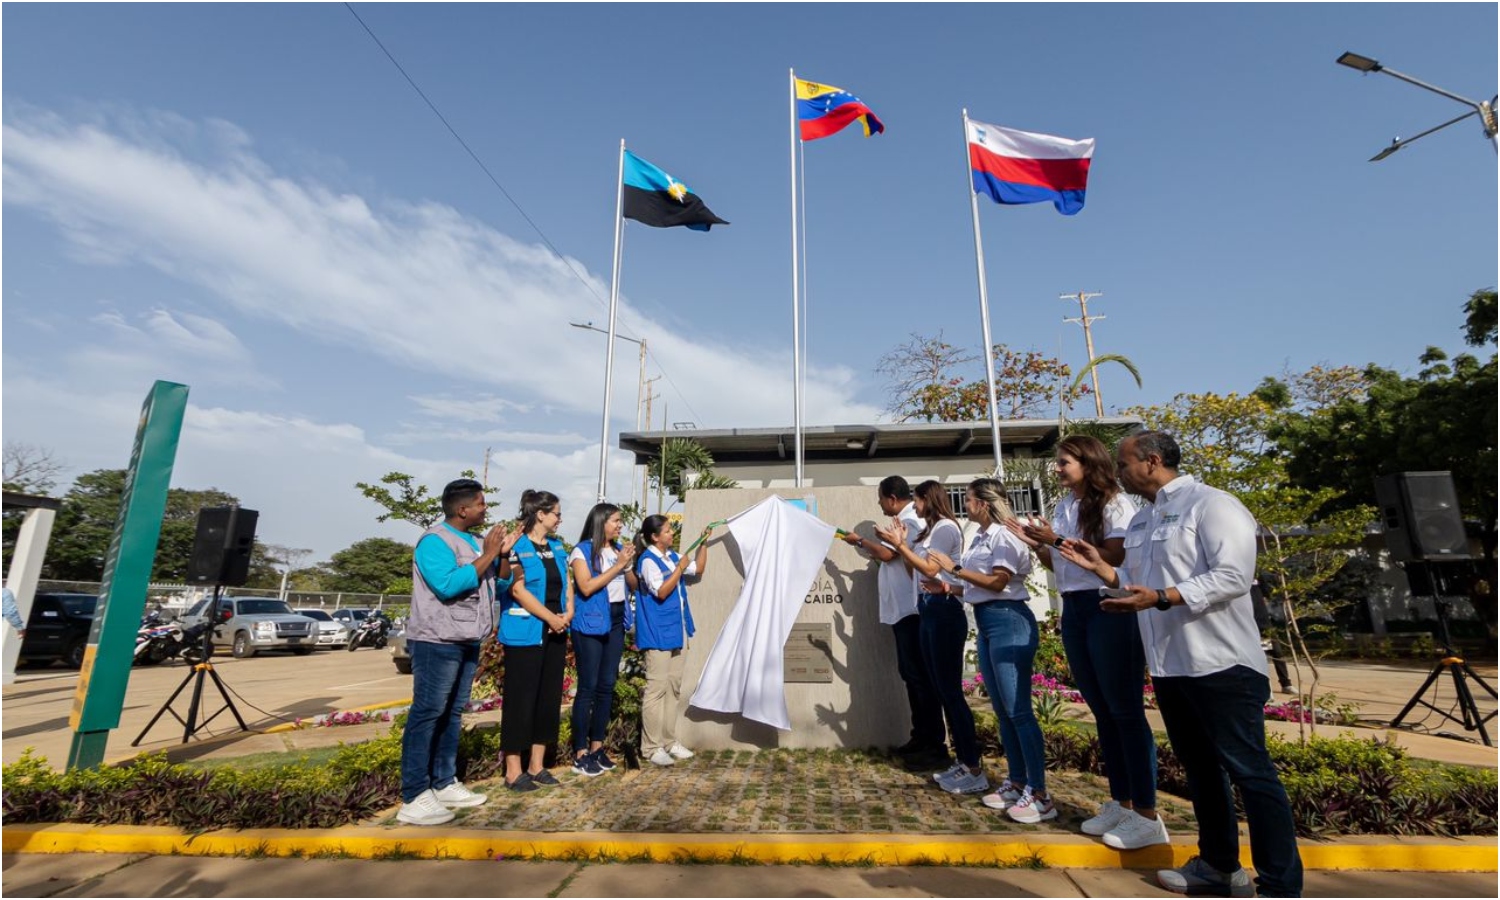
42, 470, 240, 582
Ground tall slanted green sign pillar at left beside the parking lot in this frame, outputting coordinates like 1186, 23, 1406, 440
68, 381, 188, 770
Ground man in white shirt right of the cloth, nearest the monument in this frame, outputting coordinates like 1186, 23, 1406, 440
845, 476, 948, 770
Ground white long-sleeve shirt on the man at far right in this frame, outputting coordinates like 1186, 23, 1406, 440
1121, 476, 1266, 678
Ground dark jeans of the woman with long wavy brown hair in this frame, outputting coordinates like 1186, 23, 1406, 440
1062, 590, 1157, 809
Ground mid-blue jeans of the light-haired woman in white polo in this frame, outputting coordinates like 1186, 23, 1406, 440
974, 600, 1047, 794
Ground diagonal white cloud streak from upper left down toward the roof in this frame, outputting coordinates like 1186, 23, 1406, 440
5, 113, 878, 426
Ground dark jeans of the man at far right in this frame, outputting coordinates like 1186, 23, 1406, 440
1154, 666, 1302, 897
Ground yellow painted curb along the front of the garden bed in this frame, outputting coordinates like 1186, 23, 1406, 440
3, 825, 1500, 872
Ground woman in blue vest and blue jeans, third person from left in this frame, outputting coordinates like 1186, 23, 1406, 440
567, 503, 636, 779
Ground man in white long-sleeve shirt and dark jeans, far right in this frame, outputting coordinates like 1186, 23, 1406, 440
1062, 432, 1302, 897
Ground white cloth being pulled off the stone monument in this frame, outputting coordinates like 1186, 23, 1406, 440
689, 497, 834, 731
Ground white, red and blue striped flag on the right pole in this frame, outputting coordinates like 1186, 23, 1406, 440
968, 119, 1094, 216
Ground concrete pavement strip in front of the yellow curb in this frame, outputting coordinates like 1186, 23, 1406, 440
3, 854, 1496, 897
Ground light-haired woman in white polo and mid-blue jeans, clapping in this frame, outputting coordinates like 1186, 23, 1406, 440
927, 479, 1058, 824
